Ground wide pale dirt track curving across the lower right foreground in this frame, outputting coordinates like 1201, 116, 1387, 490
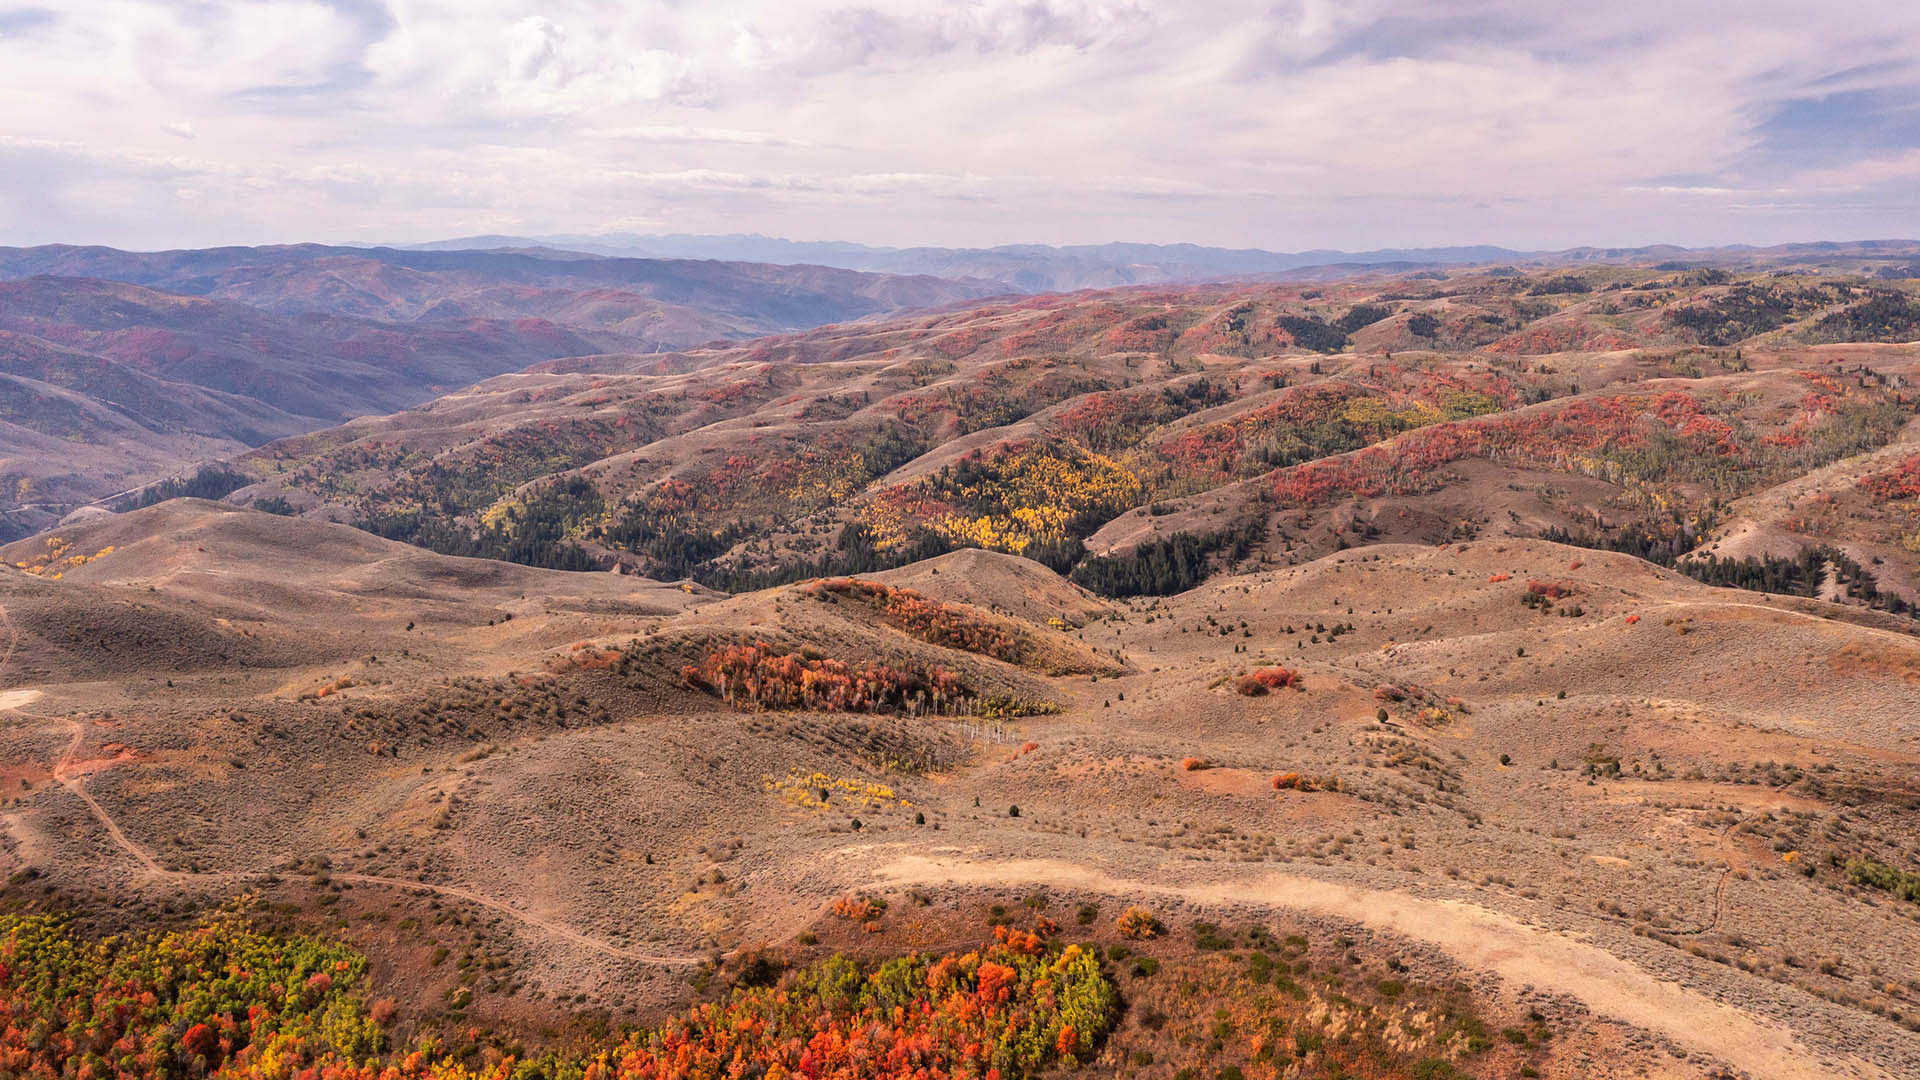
876, 855, 1891, 1080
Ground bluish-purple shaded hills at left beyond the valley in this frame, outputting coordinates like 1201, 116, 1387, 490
0, 246, 993, 536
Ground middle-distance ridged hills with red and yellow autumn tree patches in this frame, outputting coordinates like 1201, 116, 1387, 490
217, 267, 1920, 603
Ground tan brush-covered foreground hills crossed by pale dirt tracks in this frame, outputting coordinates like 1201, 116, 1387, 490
0, 526, 1920, 1080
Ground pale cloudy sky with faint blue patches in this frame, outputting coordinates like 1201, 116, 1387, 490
0, 0, 1920, 250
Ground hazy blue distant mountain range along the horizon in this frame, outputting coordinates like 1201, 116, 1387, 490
409, 233, 1920, 292
